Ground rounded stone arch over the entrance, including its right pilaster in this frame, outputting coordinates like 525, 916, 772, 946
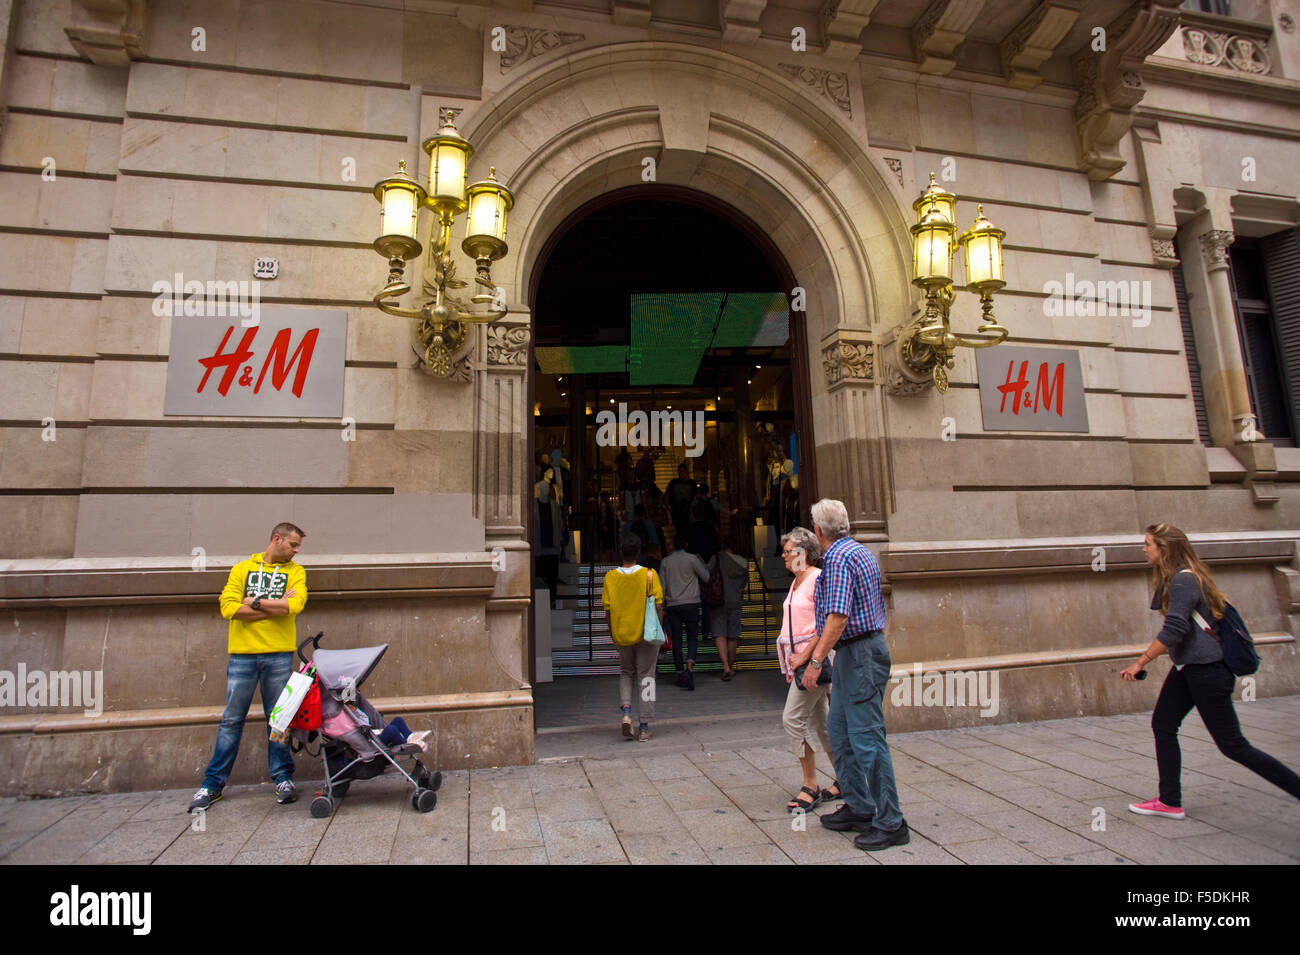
462, 42, 913, 535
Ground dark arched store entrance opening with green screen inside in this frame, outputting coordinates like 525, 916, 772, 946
529, 185, 816, 678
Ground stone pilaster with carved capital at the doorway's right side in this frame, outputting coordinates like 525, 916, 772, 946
818, 329, 889, 541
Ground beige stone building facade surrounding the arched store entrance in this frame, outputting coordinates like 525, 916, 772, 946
0, 0, 1300, 793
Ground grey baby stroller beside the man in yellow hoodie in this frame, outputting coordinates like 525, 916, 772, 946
294, 633, 442, 819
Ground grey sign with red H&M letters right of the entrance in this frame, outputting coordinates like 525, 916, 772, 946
975, 344, 1088, 433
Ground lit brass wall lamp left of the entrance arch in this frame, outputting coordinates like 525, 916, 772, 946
373, 109, 515, 378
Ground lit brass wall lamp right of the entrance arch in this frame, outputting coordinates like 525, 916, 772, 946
900, 173, 1009, 394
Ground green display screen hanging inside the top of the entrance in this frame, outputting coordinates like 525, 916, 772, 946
536, 292, 790, 385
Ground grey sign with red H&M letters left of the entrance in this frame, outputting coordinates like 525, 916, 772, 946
163, 305, 347, 418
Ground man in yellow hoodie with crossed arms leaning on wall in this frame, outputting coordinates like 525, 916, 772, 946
189, 522, 307, 812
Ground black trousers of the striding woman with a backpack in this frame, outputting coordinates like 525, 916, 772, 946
1151, 663, 1300, 806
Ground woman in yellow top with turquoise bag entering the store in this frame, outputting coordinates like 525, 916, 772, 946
601, 534, 663, 743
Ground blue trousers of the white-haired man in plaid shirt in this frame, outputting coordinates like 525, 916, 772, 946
826, 630, 904, 832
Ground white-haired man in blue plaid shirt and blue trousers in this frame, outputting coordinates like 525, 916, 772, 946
803, 499, 910, 852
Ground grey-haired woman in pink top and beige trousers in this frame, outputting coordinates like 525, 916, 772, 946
776, 528, 842, 812
